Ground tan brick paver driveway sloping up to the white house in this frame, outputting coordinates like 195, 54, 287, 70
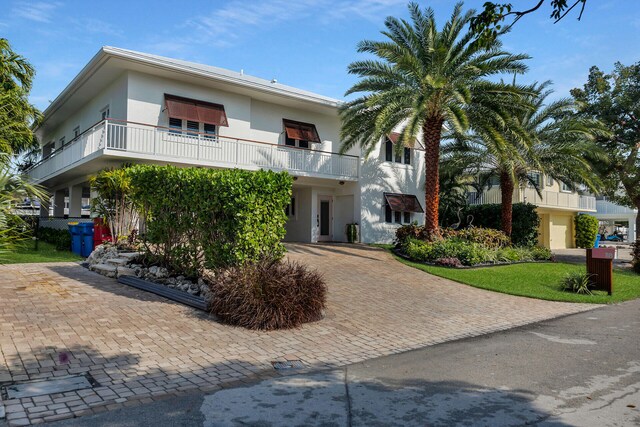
0, 244, 593, 425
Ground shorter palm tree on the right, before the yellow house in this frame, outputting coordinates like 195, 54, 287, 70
447, 81, 607, 236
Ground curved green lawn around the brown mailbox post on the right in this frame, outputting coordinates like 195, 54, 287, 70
386, 246, 640, 304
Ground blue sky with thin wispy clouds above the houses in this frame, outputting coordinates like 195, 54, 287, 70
0, 0, 640, 109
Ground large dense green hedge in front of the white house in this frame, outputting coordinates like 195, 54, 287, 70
127, 165, 293, 277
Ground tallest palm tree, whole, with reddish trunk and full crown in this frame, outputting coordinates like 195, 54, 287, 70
340, 3, 528, 235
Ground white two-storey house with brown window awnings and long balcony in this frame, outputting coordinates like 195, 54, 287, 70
29, 47, 424, 242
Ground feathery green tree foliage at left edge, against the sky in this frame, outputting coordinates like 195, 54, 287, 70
0, 38, 40, 163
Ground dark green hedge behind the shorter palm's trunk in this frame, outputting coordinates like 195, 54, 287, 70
462, 203, 540, 246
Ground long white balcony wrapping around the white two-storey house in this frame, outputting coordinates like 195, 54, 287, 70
28, 119, 360, 183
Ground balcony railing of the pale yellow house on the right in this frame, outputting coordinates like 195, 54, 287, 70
468, 187, 596, 212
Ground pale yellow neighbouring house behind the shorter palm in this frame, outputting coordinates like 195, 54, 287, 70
469, 173, 596, 249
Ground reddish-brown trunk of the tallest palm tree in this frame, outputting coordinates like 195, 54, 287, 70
422, 117, 444, 236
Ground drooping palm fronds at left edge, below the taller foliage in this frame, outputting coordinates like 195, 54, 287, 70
0, 158, 47, 256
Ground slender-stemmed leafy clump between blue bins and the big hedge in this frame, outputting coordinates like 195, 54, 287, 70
89, 167, 140, 243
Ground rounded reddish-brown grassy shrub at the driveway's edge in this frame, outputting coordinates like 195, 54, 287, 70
205, 260, 327, 330
